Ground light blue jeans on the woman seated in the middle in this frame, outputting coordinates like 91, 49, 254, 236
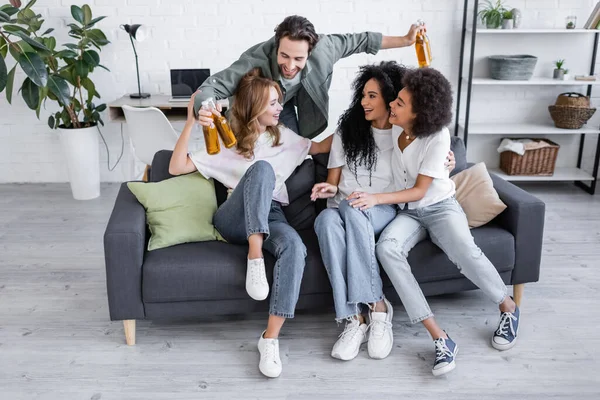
315, 200, 397, 321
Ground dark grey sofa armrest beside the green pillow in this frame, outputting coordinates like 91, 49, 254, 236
104, 183, 146, 321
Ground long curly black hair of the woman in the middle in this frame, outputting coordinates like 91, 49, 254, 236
338, 61, 406, 179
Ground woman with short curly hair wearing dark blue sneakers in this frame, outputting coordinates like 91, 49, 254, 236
351, 68, 519, 376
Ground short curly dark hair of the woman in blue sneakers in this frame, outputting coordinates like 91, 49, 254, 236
402, 68, 452, 136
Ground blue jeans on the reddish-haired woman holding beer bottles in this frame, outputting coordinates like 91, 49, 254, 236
213, 161, 306, 318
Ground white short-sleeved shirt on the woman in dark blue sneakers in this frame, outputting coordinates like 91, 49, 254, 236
392, 126, 456, 210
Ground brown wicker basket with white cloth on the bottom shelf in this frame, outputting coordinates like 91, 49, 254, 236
500, 139, 560, 176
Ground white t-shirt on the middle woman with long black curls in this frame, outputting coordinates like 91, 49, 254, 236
327, 128, 393, 208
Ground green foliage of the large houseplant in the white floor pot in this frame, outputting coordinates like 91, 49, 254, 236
0, 0, 110, 129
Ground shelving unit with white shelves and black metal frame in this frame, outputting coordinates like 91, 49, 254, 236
455, 0, 600, 194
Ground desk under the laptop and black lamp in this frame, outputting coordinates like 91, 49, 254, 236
108, 94, 188, 122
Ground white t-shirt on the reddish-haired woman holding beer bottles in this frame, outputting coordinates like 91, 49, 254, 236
189, 126, 311, 205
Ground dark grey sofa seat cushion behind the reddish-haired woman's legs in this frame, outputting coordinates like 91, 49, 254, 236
142, 230, 331, 303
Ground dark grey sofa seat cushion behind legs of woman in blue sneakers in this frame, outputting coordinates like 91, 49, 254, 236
382, 224, 515, 286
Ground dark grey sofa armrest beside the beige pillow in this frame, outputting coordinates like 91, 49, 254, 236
490, 173, 546, 285
